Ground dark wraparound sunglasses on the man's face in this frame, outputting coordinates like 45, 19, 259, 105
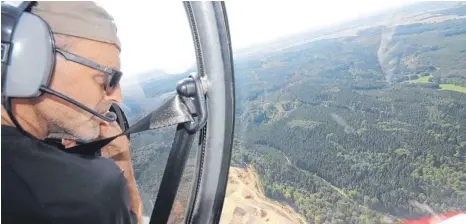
55, 48, 123, 93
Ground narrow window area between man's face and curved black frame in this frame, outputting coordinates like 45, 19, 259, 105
98, 1, 197, 222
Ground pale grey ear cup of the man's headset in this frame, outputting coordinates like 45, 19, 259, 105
5, 12, 55, 98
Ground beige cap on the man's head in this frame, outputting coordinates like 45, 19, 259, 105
31, 1, 121, 50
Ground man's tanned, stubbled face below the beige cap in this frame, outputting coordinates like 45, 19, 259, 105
36, 35, 122, 141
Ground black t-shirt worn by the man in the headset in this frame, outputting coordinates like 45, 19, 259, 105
1, 125, 136, 224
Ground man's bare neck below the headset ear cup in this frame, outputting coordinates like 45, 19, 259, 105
1, 100, 47, 139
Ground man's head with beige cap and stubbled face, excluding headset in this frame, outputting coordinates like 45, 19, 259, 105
0, 2, 122, 140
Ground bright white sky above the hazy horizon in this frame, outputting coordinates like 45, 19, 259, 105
98, 0, 412, 78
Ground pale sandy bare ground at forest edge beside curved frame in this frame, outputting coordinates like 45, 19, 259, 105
220, 167, 306, 224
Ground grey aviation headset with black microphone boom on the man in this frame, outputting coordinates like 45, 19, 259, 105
1, 2, 116, 136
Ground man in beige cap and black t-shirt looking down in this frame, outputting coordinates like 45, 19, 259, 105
1, 2, 142, 223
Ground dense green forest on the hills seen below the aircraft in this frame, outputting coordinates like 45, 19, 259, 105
124, 3, 466, 223
